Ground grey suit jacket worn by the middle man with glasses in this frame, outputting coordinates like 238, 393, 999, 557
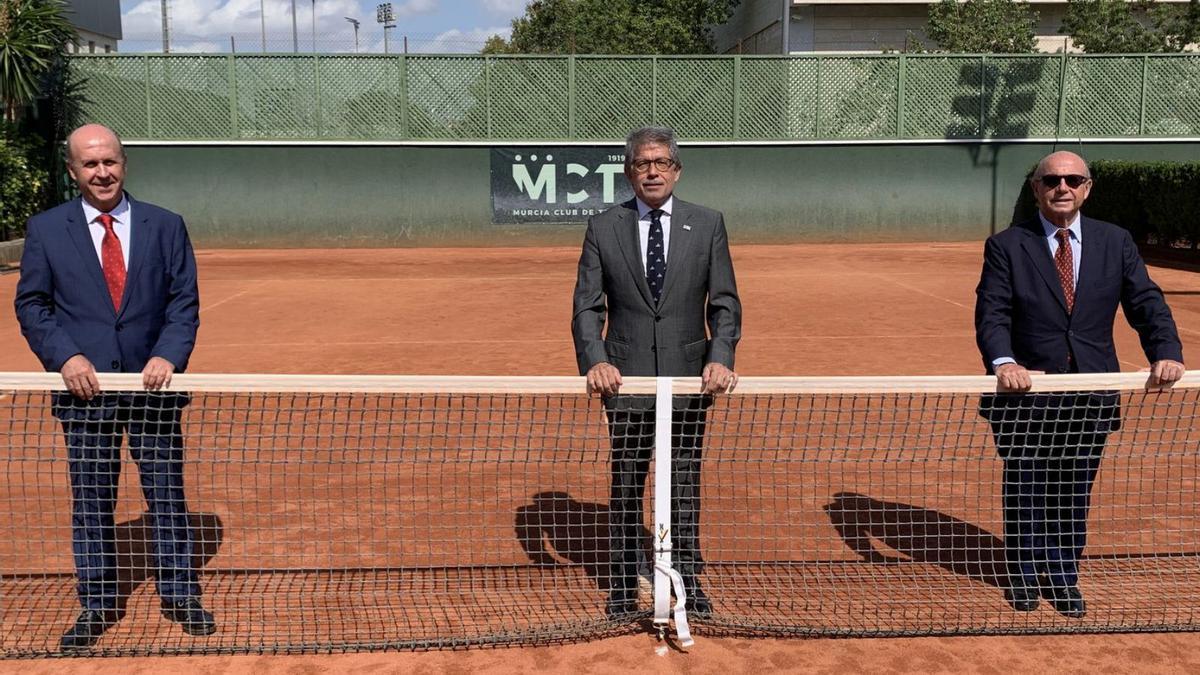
571, 197, 742, 377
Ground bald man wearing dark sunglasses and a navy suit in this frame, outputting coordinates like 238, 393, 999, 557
976, 153, 1183, 619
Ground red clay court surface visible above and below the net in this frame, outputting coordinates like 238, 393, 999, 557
0, 243, 1200, 673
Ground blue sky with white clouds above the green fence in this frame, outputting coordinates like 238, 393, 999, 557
119, 0, 528, 52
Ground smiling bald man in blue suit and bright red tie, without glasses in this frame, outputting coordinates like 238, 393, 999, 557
16, 125, 216, 650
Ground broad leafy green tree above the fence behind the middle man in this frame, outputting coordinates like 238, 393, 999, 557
484, 0, 740, 54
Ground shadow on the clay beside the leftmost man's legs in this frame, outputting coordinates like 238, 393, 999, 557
115, 513, 224, 617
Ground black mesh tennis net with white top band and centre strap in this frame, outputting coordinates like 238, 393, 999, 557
0, 374, 1200, 657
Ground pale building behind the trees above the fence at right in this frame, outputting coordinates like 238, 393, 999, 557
713, 0, 1188, 54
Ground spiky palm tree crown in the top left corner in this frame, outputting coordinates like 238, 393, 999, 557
0, 0, 76, 123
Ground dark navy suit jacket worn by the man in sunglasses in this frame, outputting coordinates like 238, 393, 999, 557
976, 211, 1183, 441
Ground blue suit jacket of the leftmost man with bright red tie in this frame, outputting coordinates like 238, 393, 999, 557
14, 195, 200, 408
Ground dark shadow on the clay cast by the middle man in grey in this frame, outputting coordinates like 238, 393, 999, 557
514, 491, 653, 591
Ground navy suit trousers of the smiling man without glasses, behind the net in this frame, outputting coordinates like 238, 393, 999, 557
62, 398, 200, 610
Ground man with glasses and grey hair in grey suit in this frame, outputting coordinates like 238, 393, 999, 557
571, 127, 742, 619
